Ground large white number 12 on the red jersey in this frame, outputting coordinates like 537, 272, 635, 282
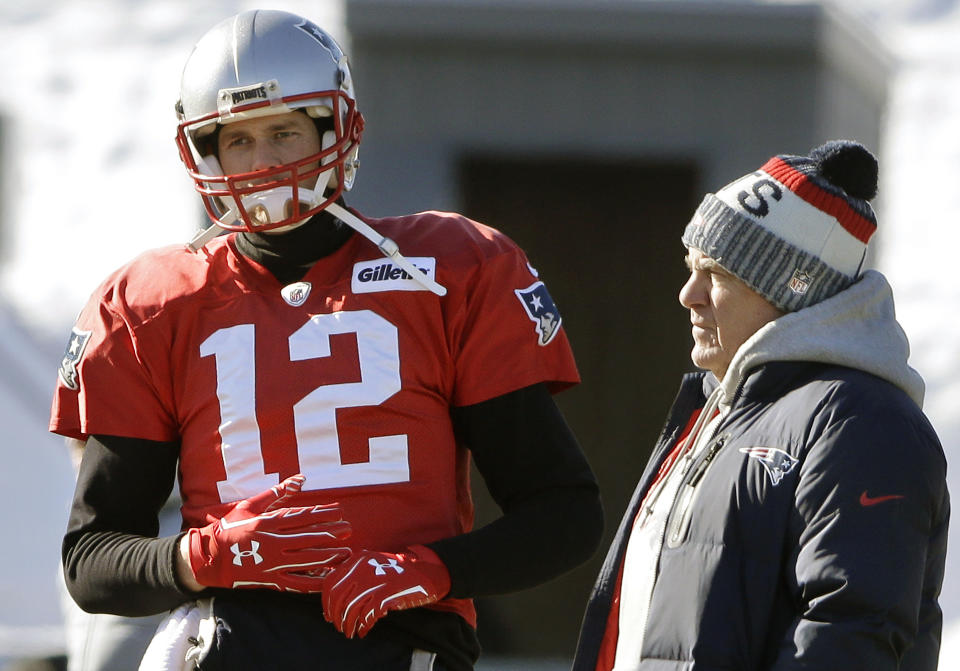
200, 310, 410, 503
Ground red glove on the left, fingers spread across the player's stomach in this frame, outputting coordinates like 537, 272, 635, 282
188, 475, 351, 592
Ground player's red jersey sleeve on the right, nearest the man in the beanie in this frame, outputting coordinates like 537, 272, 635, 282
453, 241, 580, 406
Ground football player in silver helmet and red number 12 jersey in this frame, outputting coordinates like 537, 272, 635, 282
51, 11, 602, 671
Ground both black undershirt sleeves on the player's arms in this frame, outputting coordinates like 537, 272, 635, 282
63, 384, 603, 616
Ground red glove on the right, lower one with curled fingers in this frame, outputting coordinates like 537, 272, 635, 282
323, 545, 450, 638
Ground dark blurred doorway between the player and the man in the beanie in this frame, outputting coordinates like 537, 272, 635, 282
459, 156, 701, 658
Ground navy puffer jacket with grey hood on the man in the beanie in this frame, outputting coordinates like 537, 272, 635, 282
574, 273, 949, 671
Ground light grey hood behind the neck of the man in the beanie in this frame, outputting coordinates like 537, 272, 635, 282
721, 270, 924, 407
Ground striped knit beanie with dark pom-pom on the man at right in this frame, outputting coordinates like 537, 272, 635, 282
682, 140, 878, 312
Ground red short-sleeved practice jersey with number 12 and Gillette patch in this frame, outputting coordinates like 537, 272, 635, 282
50, 212, 579, 621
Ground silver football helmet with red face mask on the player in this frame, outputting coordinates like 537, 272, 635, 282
176, 10, 363, 236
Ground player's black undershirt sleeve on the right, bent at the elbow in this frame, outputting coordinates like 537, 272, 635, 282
431, 384, 603, 597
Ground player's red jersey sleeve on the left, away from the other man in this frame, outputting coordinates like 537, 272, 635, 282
50, 294, 177, 441
